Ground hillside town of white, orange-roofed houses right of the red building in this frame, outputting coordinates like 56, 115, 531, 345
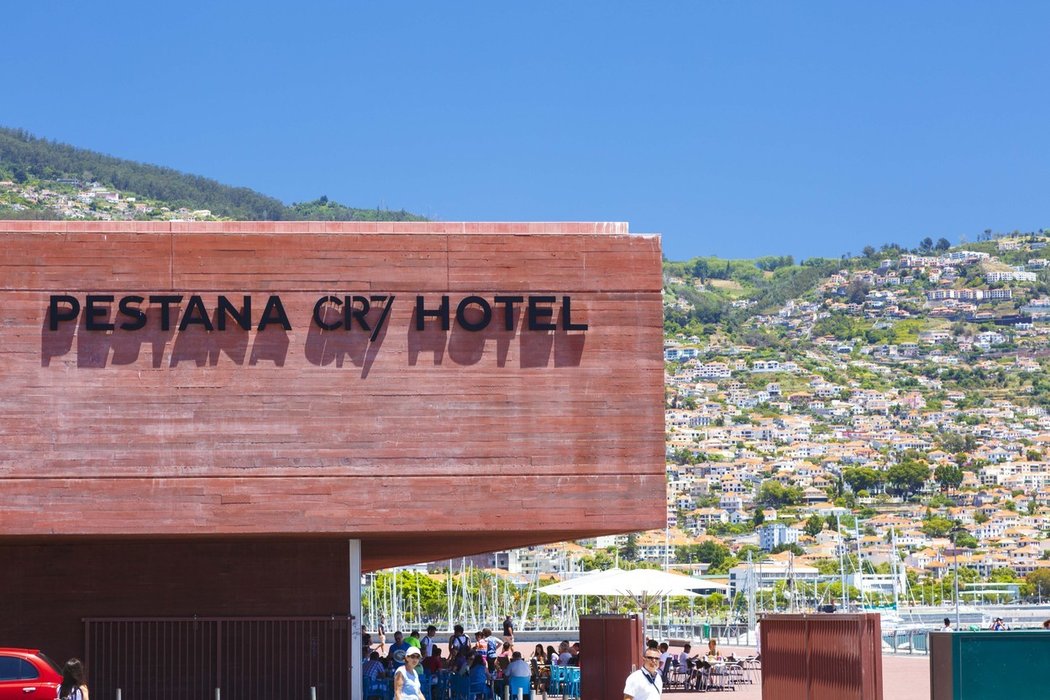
453, 232, 1050, 607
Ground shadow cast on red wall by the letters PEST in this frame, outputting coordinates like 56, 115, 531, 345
40, 309, 175, 369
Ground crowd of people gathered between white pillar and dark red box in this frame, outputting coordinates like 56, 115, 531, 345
362, 615, 580, 700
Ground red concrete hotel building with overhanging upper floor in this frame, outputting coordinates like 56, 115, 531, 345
0, 221, 665, 697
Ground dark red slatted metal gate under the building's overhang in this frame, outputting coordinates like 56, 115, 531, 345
84, 616, 353, 700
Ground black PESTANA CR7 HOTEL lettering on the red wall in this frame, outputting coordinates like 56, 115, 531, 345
47, 294, 588, 339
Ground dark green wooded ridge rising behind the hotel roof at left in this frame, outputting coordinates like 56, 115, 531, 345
0, 127, 425, 221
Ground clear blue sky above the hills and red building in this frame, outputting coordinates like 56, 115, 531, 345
0, 0, 1050, 259
